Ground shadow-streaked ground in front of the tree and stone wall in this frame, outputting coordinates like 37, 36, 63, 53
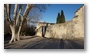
4, 37, 84, 49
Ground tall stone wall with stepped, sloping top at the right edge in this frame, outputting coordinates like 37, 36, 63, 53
73, 5, 84, 37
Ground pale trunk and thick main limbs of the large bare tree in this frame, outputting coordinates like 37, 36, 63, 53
7, 4, 32, 43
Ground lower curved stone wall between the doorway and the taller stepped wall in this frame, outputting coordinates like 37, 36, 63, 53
45, 21, 74, 39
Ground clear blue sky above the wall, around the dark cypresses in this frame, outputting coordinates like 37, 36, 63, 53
40, 4, 82, 23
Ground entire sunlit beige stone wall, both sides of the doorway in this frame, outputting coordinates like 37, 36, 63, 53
36, 5, 84, 39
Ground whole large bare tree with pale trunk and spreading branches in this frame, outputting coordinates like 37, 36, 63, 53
4, 4, 46, 43
